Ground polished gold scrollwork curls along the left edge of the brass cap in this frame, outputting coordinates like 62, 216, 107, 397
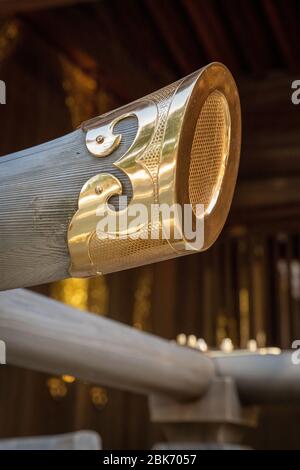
68, 100, 158, 276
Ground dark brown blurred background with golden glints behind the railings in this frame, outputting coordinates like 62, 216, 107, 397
0, 0, 300, 449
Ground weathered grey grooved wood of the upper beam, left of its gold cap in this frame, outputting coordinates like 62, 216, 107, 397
0, 117, 137, 289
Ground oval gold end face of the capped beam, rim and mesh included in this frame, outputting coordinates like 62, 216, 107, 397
176, 63, 241, 250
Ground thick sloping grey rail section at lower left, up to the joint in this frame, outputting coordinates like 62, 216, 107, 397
0, 289, 214, 398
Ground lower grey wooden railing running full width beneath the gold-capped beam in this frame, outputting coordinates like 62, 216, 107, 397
0, 289, 300, 404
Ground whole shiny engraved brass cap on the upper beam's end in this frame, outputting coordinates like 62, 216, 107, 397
68, 63, 241, 277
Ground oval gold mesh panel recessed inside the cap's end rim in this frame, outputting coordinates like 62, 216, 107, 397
189, 91, 230, 214
